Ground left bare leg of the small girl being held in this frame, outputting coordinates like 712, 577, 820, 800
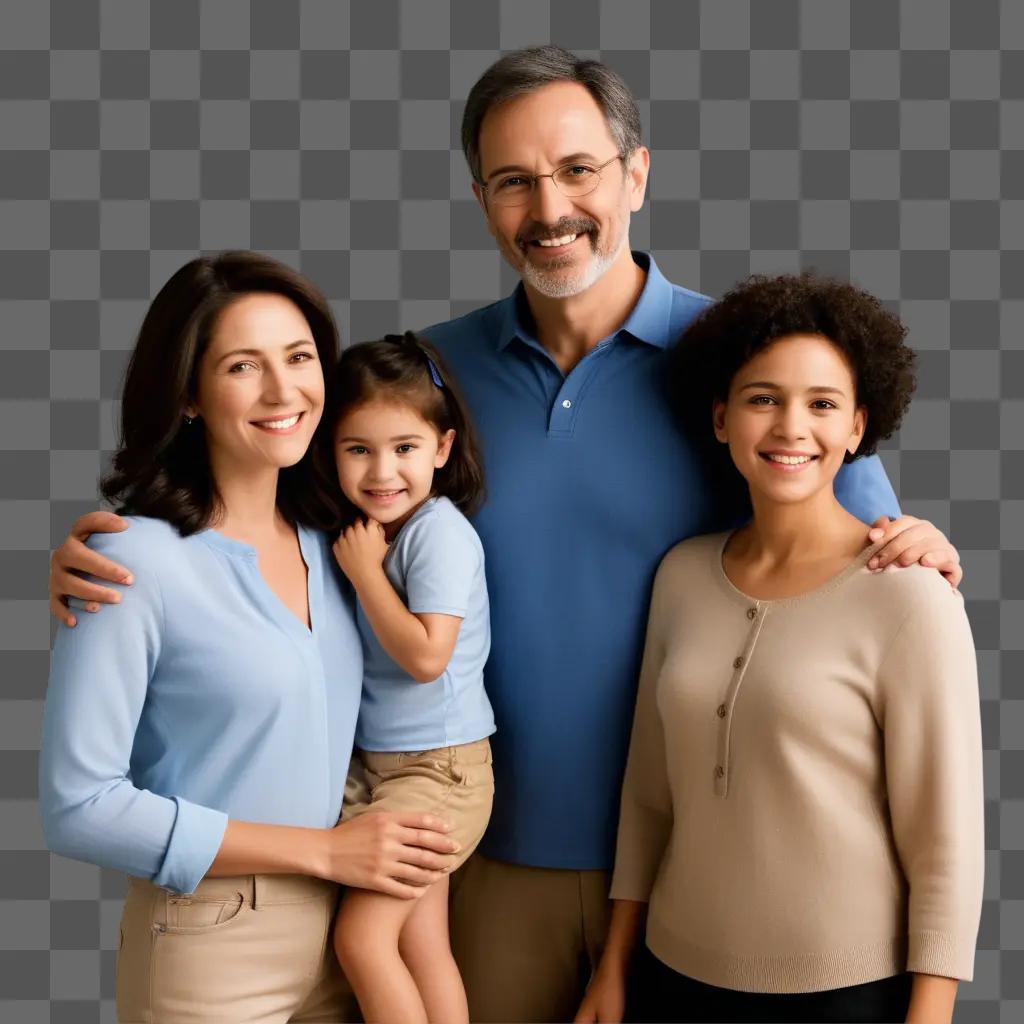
334, 889, 425, 1024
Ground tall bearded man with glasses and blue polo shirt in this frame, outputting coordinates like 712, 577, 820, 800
51, 46, 959, 1024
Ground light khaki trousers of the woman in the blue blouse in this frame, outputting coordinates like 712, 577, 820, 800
118, 874, 361, 1024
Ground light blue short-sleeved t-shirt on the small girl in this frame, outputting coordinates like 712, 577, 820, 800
355, 498, 495, 751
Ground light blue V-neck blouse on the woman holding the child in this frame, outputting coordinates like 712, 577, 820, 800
40, 517, 362, 893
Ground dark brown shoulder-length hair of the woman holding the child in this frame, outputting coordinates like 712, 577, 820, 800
101, 250, 340, 537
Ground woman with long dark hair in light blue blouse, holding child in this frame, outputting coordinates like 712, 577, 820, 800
40, 252, 454, 1022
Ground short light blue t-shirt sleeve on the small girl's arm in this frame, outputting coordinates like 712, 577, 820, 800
404, 512, 483, 618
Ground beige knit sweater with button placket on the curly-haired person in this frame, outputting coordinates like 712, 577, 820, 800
611, 534, 984, 992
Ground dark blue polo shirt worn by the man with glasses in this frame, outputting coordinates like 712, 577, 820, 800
425, 253, 898, 869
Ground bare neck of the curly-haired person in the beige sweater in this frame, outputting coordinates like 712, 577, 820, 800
740, 486, 867, 570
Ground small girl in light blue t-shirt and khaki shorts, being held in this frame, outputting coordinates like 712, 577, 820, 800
323, 333, 495, 1024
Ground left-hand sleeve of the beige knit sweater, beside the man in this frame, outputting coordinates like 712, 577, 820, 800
610, 553, 673, 903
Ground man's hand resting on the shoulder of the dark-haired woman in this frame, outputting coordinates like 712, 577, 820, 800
49, 512, 132, 626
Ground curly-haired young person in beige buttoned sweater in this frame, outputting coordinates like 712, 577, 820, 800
577, 275, 984, 1024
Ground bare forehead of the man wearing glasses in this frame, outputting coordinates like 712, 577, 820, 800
479, 82, 614, 176
